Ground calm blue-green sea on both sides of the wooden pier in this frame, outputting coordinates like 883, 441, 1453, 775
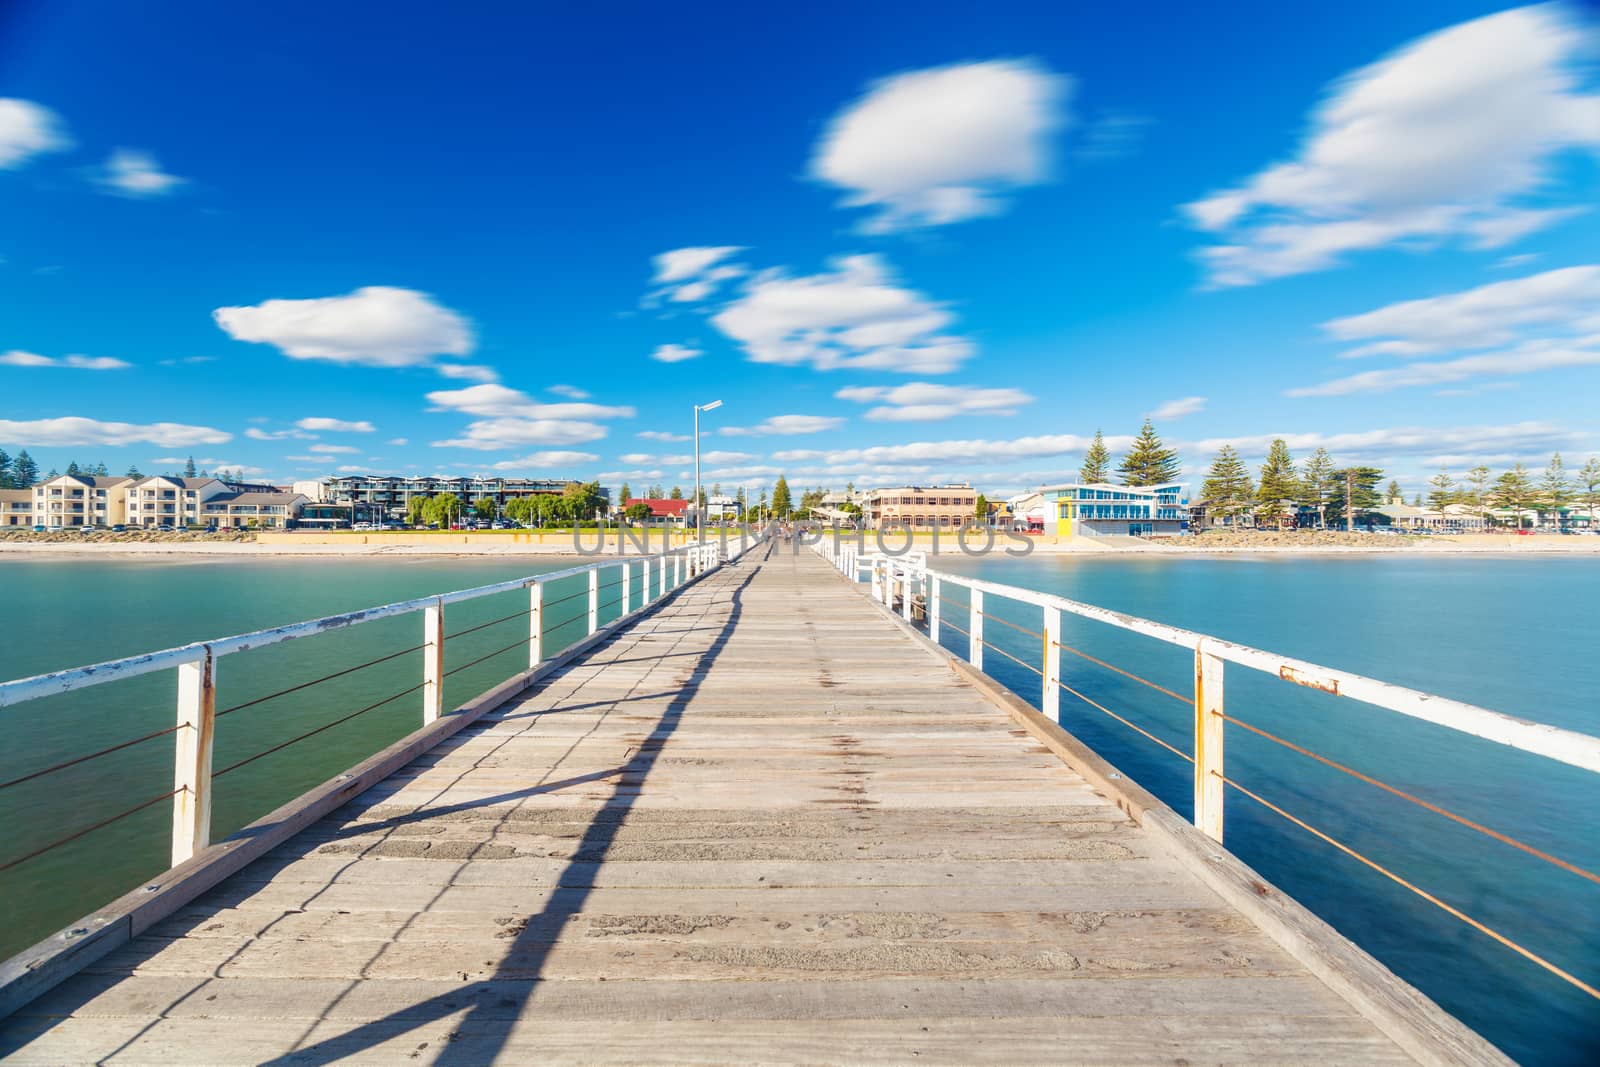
0, 557, 1600, 1064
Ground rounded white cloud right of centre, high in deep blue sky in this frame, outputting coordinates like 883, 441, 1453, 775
811, 59, 1072, 234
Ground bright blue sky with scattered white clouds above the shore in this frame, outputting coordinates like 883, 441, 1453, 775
0, 2, 1600, 491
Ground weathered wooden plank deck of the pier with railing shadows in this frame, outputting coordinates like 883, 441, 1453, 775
0, 550, 1410, 1064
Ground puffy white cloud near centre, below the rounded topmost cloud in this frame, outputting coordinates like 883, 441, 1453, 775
712, 256, 973, 374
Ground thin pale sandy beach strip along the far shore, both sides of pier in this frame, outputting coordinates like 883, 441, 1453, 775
0, 534, 1600, 565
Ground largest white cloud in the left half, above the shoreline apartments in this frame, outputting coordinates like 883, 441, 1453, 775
211, 285, 474, 366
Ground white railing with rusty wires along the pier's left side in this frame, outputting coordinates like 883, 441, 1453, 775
0, 537, 732, 869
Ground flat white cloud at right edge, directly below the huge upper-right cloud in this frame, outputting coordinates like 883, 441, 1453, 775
1322, 266, 1600, 355
